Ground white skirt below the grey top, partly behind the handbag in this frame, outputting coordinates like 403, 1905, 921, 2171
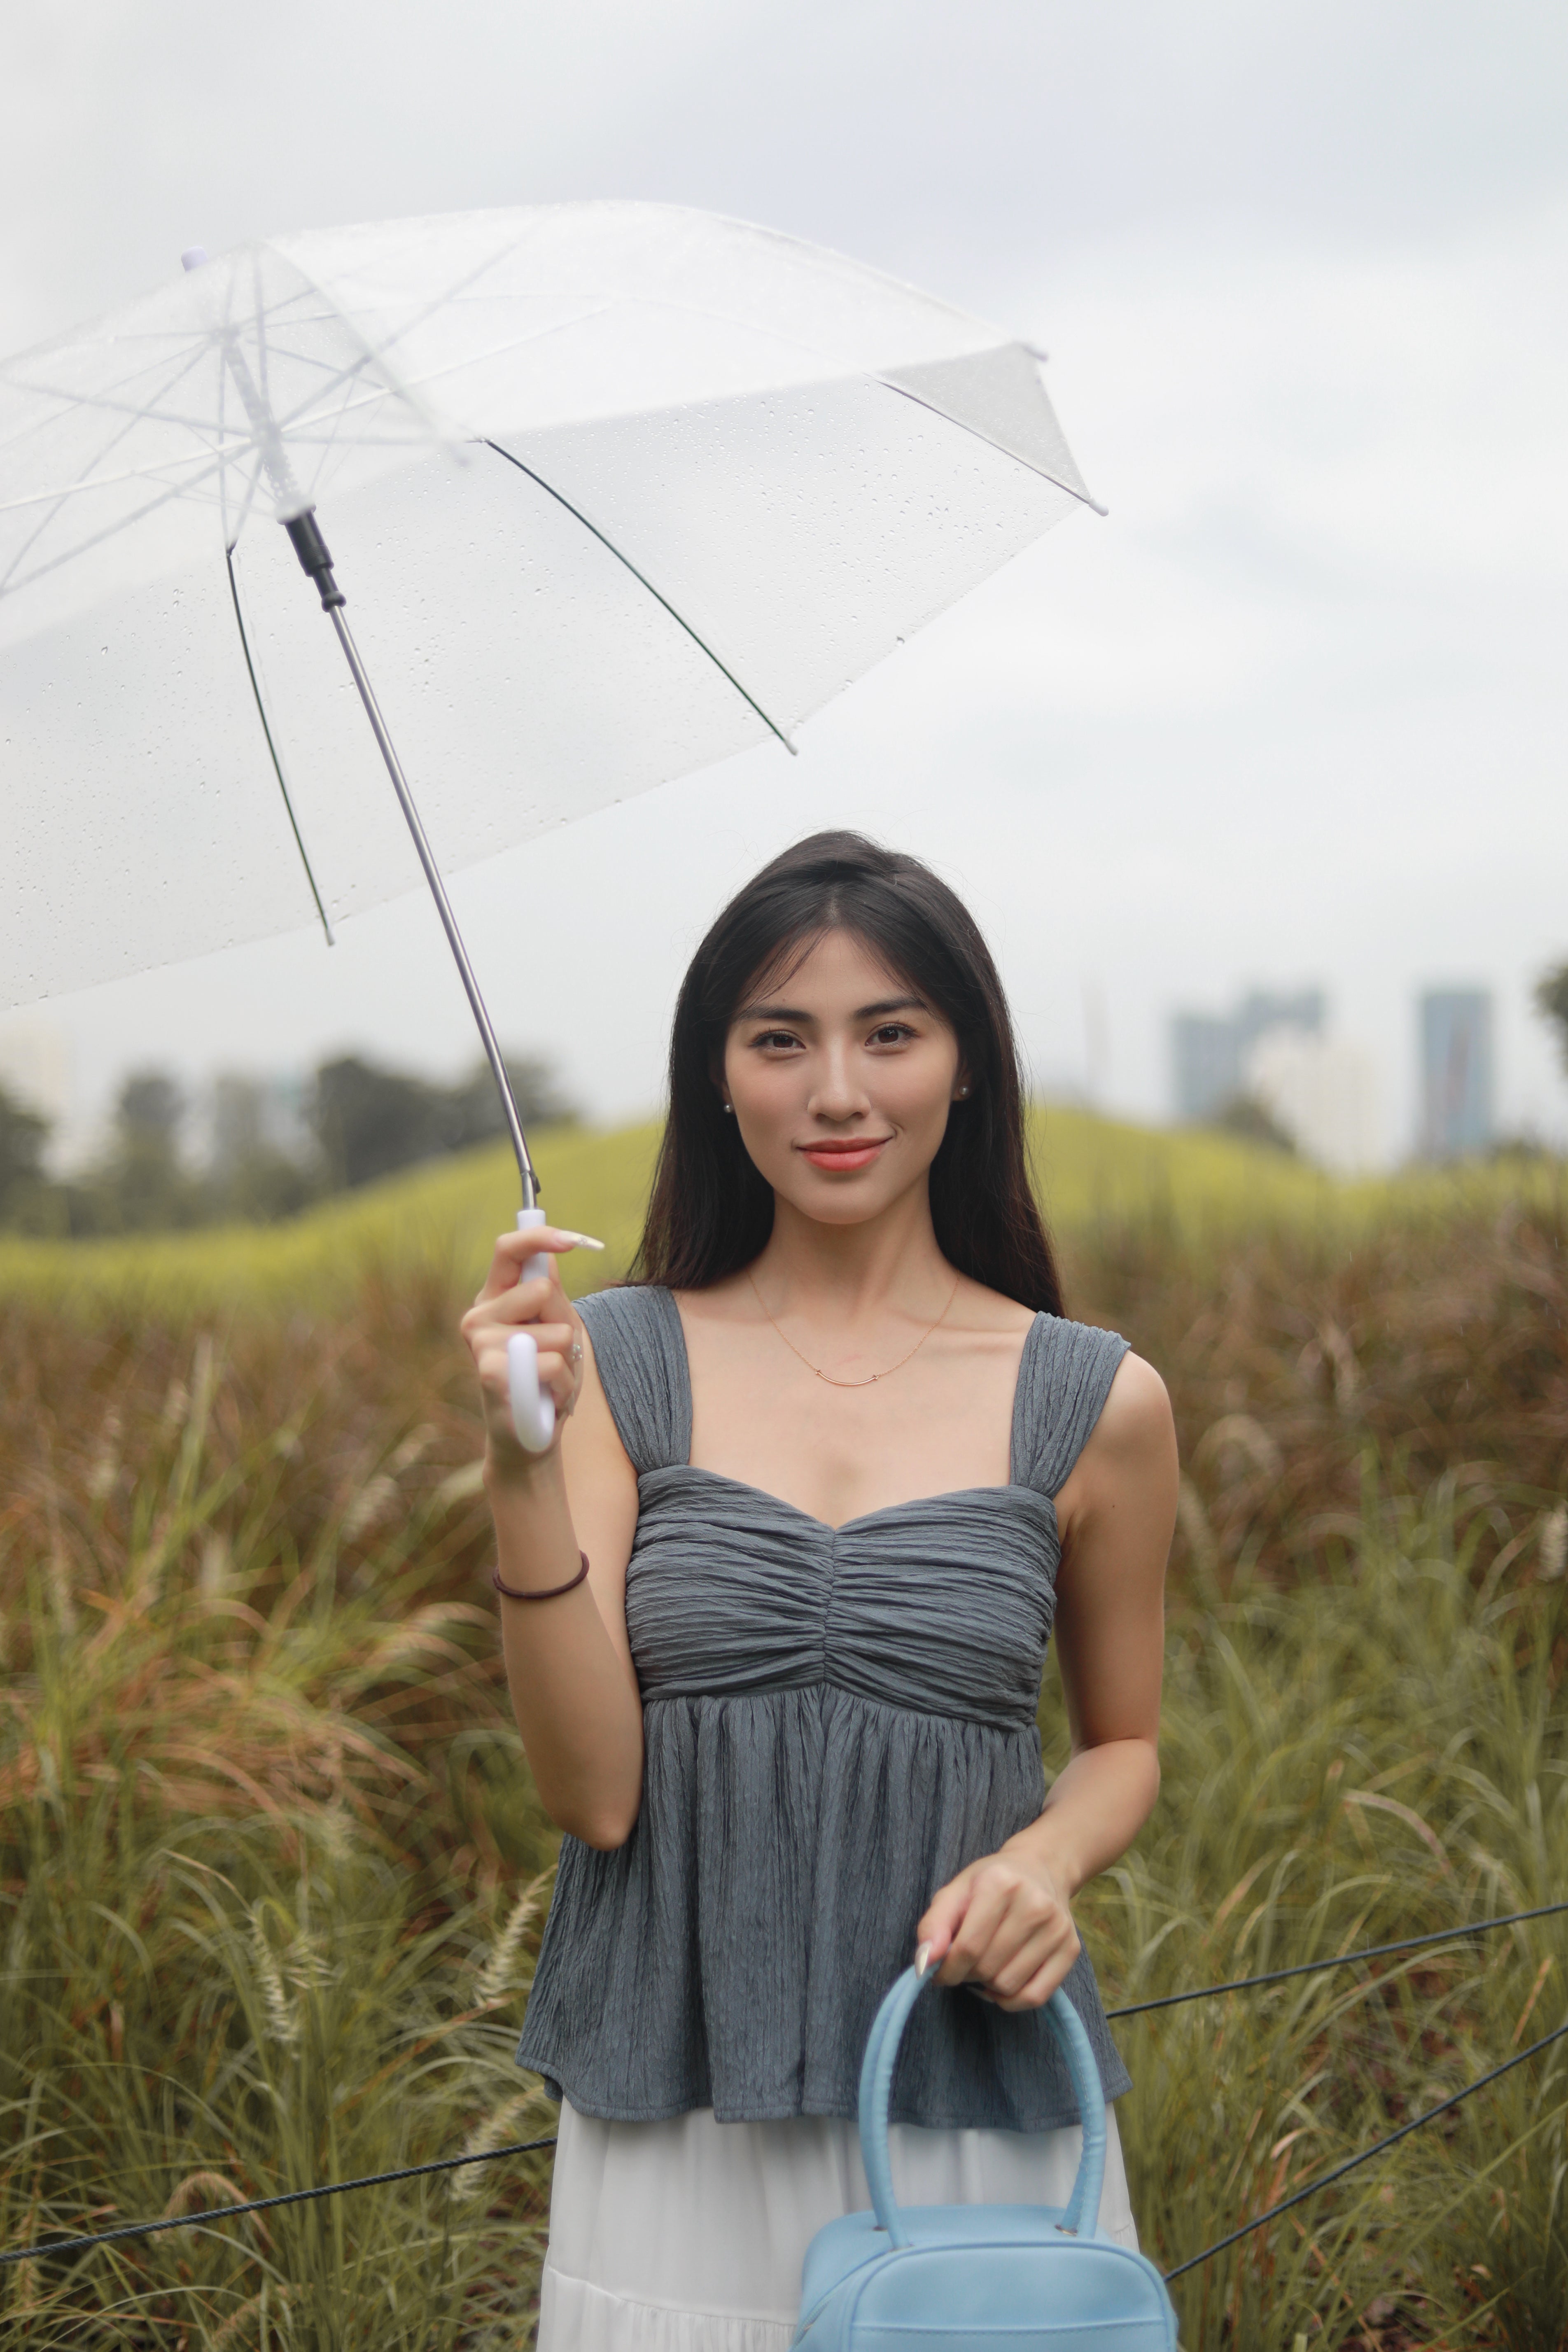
538, 2100, 1138, 2352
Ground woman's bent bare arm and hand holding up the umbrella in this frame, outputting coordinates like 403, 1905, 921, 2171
463, 1225, 642, 1849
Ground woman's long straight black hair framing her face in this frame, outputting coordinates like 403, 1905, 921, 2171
632, 833, 1063, 1315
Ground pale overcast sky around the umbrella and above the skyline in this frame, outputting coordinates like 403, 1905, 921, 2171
0, 0, 1568, 1153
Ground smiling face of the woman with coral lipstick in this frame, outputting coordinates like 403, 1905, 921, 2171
719, 931, 964, 1225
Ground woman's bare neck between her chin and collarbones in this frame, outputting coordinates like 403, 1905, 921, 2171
752, 1178, 952, 1324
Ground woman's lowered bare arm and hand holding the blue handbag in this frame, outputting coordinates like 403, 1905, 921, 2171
917, 1355, 1178, 2009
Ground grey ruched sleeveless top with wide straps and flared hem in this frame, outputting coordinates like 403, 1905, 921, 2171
517, 1286, 1128, 2131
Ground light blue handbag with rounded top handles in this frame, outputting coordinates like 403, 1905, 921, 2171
795, 1969, 1176, 2352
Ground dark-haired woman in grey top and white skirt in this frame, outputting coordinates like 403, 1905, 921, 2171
463, 833, 1176, 2352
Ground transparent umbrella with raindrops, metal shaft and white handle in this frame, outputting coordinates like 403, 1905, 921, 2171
0, 205, 1093, 1442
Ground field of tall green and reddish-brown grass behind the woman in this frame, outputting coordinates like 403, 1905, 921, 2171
0, 1113, 1568, 2352
